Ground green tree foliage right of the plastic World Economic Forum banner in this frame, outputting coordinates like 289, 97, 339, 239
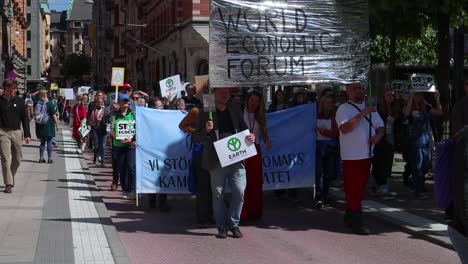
369, 0, 468, 65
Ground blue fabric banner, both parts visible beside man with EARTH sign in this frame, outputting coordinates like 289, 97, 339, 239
136, 104, 316, 194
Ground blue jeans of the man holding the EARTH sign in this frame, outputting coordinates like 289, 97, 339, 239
210, 162, 247, 228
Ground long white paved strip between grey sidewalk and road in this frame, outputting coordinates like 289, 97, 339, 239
62, 130, 115, 264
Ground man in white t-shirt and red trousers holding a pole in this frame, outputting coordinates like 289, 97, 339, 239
336, 83, 385, 235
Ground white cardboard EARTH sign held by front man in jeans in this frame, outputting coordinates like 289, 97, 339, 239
214, 129, 257, 168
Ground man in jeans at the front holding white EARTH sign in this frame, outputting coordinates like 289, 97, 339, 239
193, 88, 255, 238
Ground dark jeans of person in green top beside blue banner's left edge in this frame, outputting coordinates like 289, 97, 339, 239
112, 147, 136, 192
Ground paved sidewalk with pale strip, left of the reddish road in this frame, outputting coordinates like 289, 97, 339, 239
0, 123, 129, 264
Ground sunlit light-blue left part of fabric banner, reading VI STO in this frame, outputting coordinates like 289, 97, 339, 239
136, 107, 192, 193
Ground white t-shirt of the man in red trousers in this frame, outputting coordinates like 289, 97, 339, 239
336, 103, 384, 160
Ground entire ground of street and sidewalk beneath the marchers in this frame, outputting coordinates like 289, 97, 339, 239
0, 127, 460, 264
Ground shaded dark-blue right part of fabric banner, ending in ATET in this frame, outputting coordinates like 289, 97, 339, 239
262, 104, 317, 190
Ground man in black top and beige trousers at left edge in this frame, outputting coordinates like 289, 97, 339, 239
0, 79, 31, 193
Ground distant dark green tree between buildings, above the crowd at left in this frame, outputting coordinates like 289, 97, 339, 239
63, 53, 91, 86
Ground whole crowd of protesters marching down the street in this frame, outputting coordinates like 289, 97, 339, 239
0, 77, 458, 238
